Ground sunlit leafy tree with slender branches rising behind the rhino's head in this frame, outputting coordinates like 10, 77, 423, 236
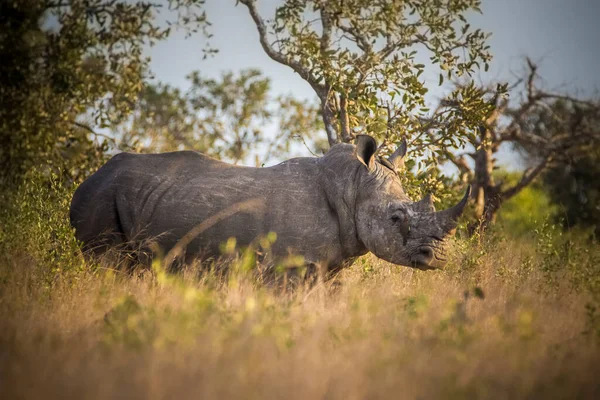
239, 0, 492, 196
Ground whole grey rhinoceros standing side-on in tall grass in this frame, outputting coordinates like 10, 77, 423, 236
70, 135, 470, 271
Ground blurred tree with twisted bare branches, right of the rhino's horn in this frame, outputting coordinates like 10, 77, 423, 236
441, 60, 600, 227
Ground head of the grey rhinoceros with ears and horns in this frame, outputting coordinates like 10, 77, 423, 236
354, 135, 471, 269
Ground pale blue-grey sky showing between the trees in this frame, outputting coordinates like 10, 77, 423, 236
147, 0, 600, 169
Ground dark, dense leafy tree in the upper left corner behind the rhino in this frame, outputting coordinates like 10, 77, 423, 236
0, 0, 206, 187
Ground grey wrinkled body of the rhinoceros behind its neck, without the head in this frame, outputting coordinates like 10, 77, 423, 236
72, 152, 339, 262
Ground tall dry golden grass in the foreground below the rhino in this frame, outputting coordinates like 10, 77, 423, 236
0, 236, 600, 399
